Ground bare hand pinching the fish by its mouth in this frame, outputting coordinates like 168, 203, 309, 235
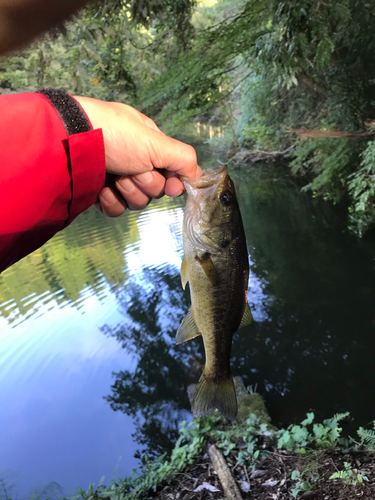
75, 96, 202, 217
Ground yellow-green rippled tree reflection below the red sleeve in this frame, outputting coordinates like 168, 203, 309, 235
0, 209, 135, 322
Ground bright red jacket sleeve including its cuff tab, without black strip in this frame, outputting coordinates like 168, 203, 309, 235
0, 93, 105, 272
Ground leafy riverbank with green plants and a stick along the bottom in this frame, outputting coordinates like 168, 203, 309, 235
63, 377, 375, 500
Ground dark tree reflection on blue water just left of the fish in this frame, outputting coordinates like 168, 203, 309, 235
102, 268, 202, 455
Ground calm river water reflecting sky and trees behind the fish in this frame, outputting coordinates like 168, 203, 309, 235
0, 135, 375, 498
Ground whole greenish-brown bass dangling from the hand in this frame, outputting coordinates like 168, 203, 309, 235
176, 165, 253, 420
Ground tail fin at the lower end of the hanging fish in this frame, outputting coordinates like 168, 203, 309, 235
192, 372, 237, 420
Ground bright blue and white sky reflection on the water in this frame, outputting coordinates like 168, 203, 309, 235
0, 200, 192, 494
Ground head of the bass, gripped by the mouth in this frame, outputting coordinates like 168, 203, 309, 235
181, 165, 241, 251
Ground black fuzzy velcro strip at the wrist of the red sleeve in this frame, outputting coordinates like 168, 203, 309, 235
37, 89, 92, 135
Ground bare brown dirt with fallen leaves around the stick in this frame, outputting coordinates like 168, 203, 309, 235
150, 448, 375, 500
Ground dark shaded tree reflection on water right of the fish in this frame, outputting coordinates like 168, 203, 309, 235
232, 168, 375, 425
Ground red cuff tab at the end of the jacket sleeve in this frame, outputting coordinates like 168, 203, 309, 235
66, 129, 105, 225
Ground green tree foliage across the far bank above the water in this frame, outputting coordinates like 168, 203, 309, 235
0, 0, 375, 235
